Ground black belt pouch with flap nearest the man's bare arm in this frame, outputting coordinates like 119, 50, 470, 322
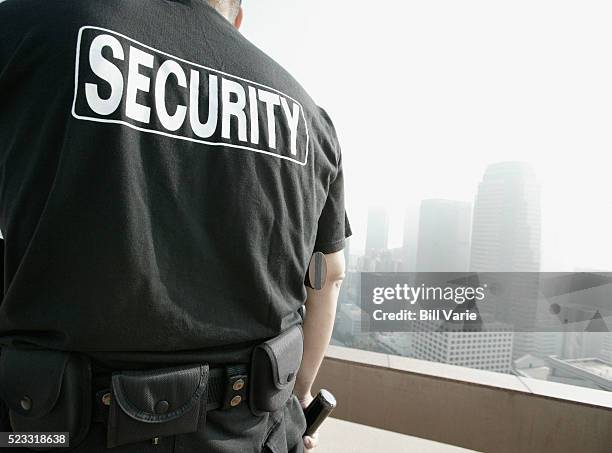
249, 324, 304, 415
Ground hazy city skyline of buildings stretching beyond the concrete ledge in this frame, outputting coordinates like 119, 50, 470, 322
335, 158, 612, 388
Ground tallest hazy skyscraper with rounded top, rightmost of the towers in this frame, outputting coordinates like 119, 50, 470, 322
470, 162, 540, 358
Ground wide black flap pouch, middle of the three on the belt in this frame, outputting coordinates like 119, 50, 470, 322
107, 364, 209, 448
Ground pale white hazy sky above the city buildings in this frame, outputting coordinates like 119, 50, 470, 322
243, 0, 612, 270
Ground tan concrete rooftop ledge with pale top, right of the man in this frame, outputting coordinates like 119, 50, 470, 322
315, 346, 612, 453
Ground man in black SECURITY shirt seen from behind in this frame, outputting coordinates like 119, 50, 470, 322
0, 0, 350, 453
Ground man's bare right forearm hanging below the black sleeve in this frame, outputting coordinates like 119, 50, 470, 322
294, 251, 346, 404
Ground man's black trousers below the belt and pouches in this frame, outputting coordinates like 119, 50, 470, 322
0, 380, 306, 453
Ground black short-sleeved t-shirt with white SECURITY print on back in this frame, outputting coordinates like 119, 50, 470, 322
0, 0, 350, 360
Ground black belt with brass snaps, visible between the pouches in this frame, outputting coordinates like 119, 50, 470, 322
92, 365, 248, 422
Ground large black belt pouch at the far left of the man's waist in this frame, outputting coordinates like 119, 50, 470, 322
0, 347, 91, 451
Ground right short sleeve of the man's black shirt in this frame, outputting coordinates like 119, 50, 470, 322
314, 110, 352, 254
